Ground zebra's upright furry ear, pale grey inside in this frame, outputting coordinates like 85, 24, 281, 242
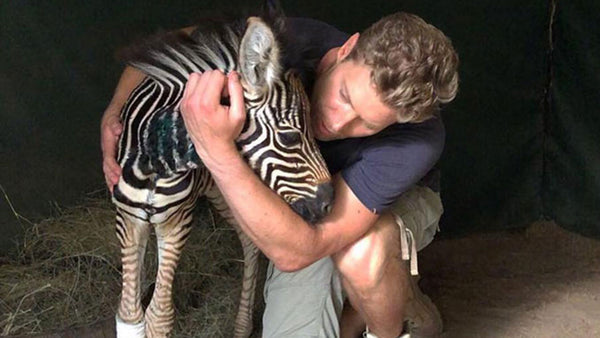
239, 17, 281, 93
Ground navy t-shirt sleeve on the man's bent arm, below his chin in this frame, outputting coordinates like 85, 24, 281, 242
342, 118, 445, 214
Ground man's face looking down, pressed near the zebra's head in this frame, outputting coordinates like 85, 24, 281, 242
311, 60, 396, 141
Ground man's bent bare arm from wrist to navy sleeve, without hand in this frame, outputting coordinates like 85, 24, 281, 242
211, 154, 379, 271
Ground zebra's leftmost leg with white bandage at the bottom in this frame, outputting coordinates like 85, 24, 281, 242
116, 209, 150, 338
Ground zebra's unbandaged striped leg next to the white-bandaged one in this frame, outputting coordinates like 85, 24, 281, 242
145, 217, 192, 338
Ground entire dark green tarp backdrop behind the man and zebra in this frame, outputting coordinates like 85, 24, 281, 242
0, 0, 600, 252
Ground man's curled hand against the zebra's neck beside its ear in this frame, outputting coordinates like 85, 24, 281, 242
181, 70, 246, 170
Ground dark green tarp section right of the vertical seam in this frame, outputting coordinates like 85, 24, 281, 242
544, 1, 600, 237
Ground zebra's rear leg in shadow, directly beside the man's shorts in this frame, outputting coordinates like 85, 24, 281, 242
206, 186, 260, 338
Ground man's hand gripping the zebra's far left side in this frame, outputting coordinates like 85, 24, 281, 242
100, 111, 123, 193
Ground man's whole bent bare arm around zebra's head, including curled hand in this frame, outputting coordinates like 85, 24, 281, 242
181, 71, 378, 271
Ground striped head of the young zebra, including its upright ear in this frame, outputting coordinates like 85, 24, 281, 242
237, 17, 333, 223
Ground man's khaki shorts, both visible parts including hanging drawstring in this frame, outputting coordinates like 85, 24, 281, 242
262, 186, 443, 338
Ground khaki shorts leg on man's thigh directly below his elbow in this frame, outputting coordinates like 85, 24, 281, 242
263, 257, 343, 338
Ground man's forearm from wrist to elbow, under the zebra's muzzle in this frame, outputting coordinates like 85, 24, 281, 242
211, 148, 323, 271
